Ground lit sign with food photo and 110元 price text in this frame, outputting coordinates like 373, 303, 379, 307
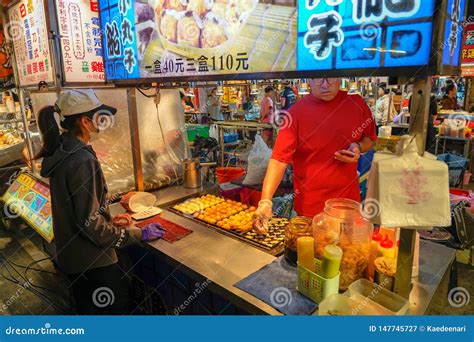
100, 0, 297, 80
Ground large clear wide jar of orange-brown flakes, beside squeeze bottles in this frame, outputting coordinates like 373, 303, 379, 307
312, 198, 374, 290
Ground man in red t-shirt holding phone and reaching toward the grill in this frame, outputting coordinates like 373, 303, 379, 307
254, 78, 377, 233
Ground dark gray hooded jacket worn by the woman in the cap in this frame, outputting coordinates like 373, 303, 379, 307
41, 133, 141, 274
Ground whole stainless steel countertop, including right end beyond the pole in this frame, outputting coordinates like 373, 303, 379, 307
111, 185, 455, 315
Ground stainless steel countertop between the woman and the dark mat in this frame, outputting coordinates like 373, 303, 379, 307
110, 184, 280, 315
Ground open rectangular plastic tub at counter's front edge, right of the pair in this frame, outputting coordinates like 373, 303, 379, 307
349, 279, 409, 316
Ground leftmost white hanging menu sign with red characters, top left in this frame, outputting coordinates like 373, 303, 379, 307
6, 0, 54, 86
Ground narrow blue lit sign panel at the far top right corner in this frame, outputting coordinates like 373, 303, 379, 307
442, 0, 466, 66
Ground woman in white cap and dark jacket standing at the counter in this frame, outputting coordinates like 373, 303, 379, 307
36, 89, 163, 314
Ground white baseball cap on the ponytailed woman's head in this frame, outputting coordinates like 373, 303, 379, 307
55, 89, 117, 117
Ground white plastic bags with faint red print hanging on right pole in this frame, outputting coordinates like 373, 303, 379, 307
366, 138, 451, 228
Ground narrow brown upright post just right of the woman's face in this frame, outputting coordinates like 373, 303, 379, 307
127, 88, 145, 191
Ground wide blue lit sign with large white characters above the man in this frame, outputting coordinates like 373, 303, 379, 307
298, 0, 434, 70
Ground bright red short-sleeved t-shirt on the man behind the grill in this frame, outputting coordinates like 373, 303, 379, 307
272, 91, 377, 217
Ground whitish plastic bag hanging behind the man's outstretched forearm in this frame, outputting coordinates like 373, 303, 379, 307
242, 135, 272, 184
